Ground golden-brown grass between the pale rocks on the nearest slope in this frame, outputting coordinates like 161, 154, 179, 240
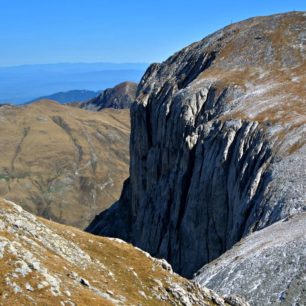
0, 199, 215, 306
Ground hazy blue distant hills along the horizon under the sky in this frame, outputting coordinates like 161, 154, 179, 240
0, 63, 149, 104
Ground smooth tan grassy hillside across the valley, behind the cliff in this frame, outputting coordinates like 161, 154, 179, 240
0, 100, 130, 228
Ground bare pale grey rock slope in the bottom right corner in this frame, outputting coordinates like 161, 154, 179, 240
195, 213, 306, 305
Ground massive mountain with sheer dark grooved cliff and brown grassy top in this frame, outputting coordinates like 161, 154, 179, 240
87, 13, 306, 277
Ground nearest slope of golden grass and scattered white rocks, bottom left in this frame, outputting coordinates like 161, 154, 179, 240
0, 199, 248, 306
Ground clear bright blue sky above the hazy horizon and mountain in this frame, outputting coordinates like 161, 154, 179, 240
0, 0, 306, 66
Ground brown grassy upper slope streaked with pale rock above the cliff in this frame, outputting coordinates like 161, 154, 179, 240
197, 13, 306, 140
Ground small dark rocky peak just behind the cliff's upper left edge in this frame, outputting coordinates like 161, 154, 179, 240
80, 82, 137, 112
